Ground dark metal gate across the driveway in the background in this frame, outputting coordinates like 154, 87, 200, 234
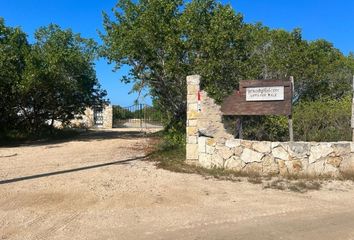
113, 104, 162, 128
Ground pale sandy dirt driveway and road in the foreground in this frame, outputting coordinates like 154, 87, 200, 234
0, 130, 354, 240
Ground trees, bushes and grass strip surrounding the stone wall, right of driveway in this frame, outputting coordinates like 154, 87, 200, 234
101, 0, 354, 192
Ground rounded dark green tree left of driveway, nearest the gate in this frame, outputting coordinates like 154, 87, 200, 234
21, 25, 106, 132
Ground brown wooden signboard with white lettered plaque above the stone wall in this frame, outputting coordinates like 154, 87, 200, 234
221, 80, 293, 116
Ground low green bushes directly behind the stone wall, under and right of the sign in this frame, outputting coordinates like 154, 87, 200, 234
224, 96, 352, 142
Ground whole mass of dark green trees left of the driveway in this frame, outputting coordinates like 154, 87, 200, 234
0, 20, 106, 136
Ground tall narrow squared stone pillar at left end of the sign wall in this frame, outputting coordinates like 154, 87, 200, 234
186, 75, 200, 164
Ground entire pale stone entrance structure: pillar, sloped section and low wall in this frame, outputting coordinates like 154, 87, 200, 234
186, 75, 354, 177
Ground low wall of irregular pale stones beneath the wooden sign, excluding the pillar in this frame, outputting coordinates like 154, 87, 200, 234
198, 137, 354, 176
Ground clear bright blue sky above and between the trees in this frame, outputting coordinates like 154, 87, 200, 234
0, 0, 354, 106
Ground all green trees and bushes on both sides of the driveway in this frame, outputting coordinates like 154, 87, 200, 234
0, 0, 354, 141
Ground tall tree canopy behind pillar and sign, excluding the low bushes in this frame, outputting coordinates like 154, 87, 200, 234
101, 0, 354, 135
